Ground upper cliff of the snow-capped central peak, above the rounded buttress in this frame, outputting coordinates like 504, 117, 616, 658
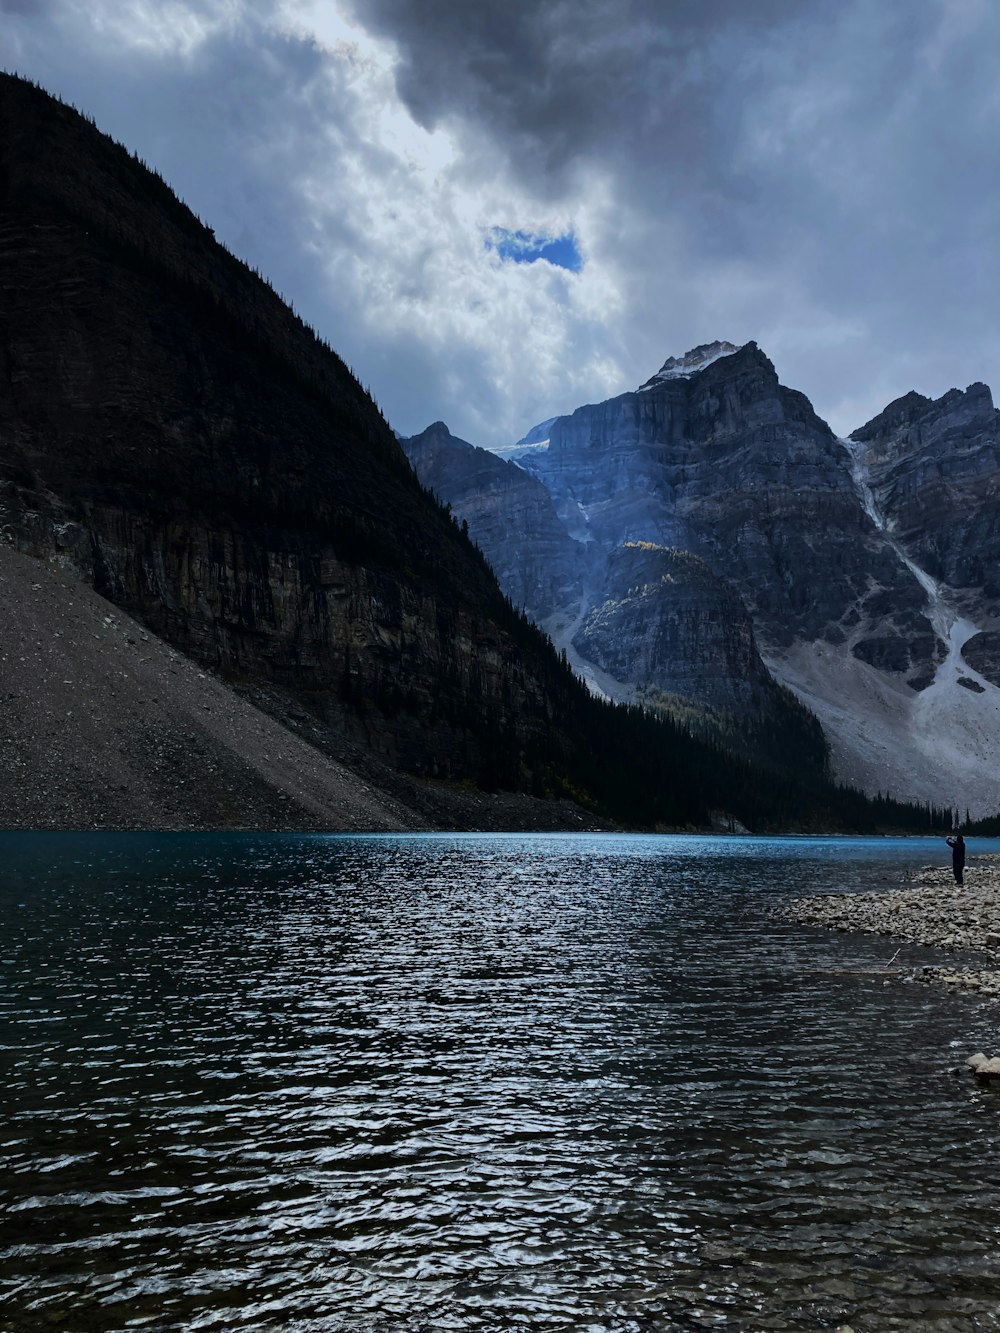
533, 343, 921, 647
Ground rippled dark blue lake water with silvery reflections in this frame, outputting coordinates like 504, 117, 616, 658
0, 834, 1000, 1333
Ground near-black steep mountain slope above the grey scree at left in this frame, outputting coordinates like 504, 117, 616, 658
0, 77, 578, 777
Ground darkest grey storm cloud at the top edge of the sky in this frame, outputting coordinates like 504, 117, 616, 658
341, 0, 826, 190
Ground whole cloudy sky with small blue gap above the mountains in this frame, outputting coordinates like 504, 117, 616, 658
0, 0, 1000, 444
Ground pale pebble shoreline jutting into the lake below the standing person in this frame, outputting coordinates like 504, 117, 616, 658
777, 849, 1000, 996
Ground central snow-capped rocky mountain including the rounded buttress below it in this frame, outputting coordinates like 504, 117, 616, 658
413, 343, 935, 778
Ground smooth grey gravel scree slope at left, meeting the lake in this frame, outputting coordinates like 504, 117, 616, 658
0, 547, 427, 830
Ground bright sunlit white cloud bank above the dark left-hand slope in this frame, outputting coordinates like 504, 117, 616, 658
0, 0, 623, 443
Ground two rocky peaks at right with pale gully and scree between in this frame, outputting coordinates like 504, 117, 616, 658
404, 343, 1000, 813
